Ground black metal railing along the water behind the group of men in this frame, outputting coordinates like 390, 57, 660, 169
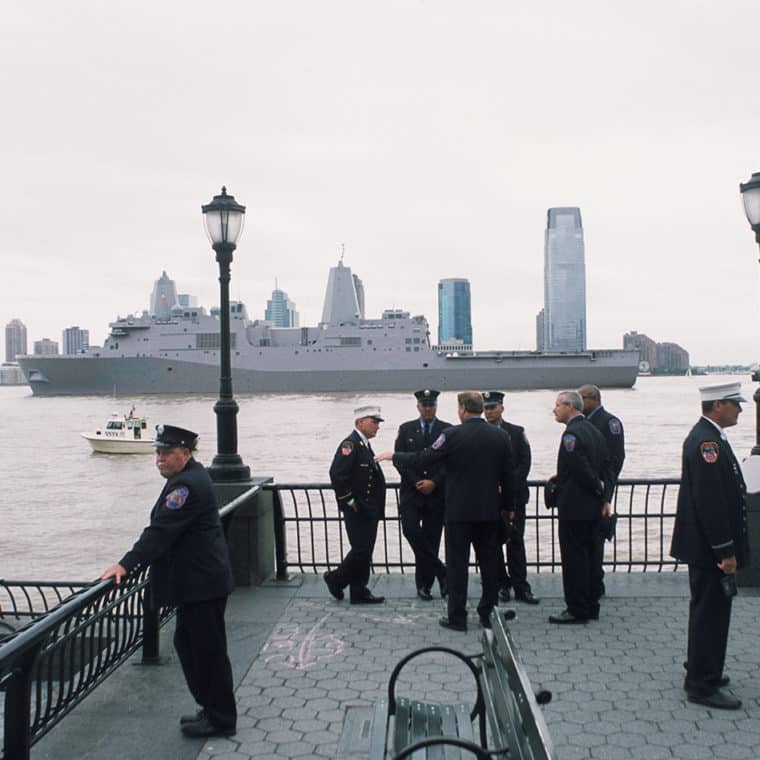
265, 478, 679, 579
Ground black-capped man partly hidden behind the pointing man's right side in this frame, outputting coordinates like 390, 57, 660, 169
483, 391, 539, 604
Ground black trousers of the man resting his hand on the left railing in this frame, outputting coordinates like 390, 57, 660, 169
174, 596, 237, 728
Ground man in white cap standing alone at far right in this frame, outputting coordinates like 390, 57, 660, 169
670, 383, 749, 710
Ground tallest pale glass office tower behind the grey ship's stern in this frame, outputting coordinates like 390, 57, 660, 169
542, 207, 586, 351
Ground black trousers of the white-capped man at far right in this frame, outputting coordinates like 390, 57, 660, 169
685, 565, 732, 696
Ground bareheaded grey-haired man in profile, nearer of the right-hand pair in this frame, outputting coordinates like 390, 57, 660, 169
549, 391, 611, 624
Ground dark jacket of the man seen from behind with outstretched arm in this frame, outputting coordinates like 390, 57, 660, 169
393, 417, 515, 523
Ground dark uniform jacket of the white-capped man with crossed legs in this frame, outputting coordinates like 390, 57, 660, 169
330, 430, 385, 520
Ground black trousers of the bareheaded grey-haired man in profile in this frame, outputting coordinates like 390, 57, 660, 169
559, 519, 599, 619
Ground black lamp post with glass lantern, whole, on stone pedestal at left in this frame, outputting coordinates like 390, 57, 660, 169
201, 187, 251, 482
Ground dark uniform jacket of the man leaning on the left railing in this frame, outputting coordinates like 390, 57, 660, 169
119, 458, 234, 606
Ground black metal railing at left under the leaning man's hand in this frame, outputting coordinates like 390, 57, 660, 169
0, 487, 259, 760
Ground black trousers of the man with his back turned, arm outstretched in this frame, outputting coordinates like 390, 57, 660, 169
446, 520, 500, 623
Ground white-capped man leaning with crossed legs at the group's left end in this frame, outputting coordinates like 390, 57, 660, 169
323, 406, 385, 604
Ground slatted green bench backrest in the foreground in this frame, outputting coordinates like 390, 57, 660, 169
481, 610, 557, 760
